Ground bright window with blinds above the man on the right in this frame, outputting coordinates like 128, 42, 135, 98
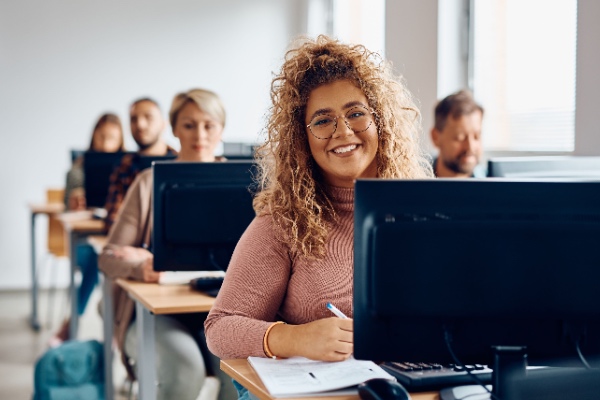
470, 0, 577, 152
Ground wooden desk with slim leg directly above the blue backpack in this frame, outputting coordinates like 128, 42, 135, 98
58, 213, 104, 339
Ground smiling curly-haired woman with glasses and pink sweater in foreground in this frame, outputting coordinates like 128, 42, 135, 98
205, 36, 432, 397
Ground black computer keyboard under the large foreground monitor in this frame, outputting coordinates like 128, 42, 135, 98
381, 362, 492, 392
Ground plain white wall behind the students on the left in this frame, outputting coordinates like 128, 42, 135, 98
0, 0, 306, 289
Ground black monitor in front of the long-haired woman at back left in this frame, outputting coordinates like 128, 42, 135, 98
83, 151, 127, 208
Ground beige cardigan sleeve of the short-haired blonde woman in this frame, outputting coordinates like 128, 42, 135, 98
98, 171, 152, 280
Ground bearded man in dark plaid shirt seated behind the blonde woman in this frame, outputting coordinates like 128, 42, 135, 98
105, 97, 176, 232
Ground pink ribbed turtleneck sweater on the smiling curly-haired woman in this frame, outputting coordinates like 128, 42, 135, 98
204, 188, 354, 359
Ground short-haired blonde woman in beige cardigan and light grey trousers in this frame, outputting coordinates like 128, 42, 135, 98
99, 89, 225, 400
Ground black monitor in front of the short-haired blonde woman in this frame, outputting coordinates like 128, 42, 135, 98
152, 161, 255, 271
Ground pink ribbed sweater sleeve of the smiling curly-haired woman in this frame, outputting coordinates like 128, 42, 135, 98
205, 216, 292, 359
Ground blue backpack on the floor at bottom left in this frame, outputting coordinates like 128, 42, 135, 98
33, 340, 104, 400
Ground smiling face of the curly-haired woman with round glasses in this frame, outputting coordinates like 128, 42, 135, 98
305, 80, 379, 187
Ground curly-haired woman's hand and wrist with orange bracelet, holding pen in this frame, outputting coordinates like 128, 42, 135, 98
267, 317, 354, 361
